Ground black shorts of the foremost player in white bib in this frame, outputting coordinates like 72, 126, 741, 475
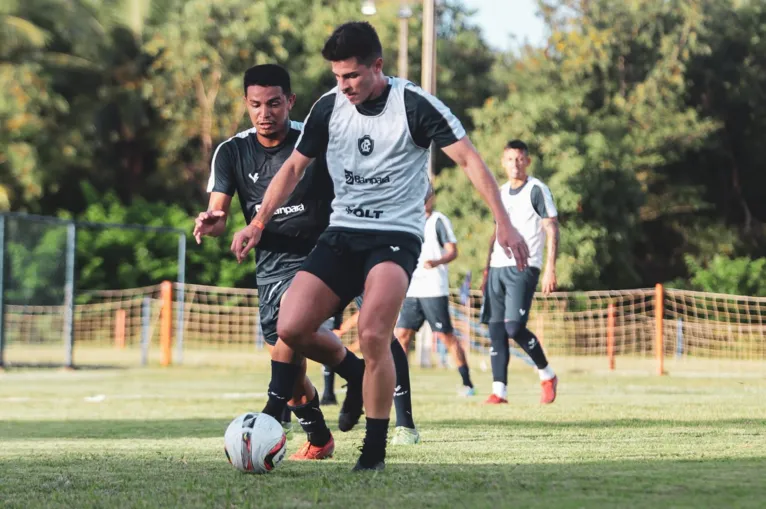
301, 228, 421, 309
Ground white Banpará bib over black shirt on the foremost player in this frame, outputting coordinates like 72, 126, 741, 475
297, 78, 465, 238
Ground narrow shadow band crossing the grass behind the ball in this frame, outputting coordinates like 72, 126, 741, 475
0, 416, 766, 442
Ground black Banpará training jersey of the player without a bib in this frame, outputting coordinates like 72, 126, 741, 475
207, 122, 333, 284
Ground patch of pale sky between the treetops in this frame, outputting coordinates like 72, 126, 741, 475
463, 0, 545, 50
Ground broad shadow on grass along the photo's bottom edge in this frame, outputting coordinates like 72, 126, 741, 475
0, 451, 766, 509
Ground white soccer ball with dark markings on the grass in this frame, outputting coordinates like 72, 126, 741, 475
223, 412, 287, 474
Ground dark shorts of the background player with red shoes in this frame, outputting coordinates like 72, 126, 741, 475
481, 267, 540, 326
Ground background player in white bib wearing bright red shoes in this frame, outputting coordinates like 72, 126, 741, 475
482, 140, 559, 404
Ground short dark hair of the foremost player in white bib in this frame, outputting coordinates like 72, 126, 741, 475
322, 21, 383, 66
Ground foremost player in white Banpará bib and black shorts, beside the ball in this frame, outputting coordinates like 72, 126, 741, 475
232, 22, 528, 470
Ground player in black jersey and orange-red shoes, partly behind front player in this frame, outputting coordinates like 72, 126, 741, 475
194, 65, 350, 460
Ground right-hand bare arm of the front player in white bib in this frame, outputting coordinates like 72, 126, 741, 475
442, 136, 529, 270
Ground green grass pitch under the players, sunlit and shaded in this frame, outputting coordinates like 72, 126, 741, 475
0, 356, 766, 509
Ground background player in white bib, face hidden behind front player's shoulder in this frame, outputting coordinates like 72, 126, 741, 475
394, 189, 475, 396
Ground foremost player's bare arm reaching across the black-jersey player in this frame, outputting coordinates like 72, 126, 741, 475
231, 150, 313, 263
